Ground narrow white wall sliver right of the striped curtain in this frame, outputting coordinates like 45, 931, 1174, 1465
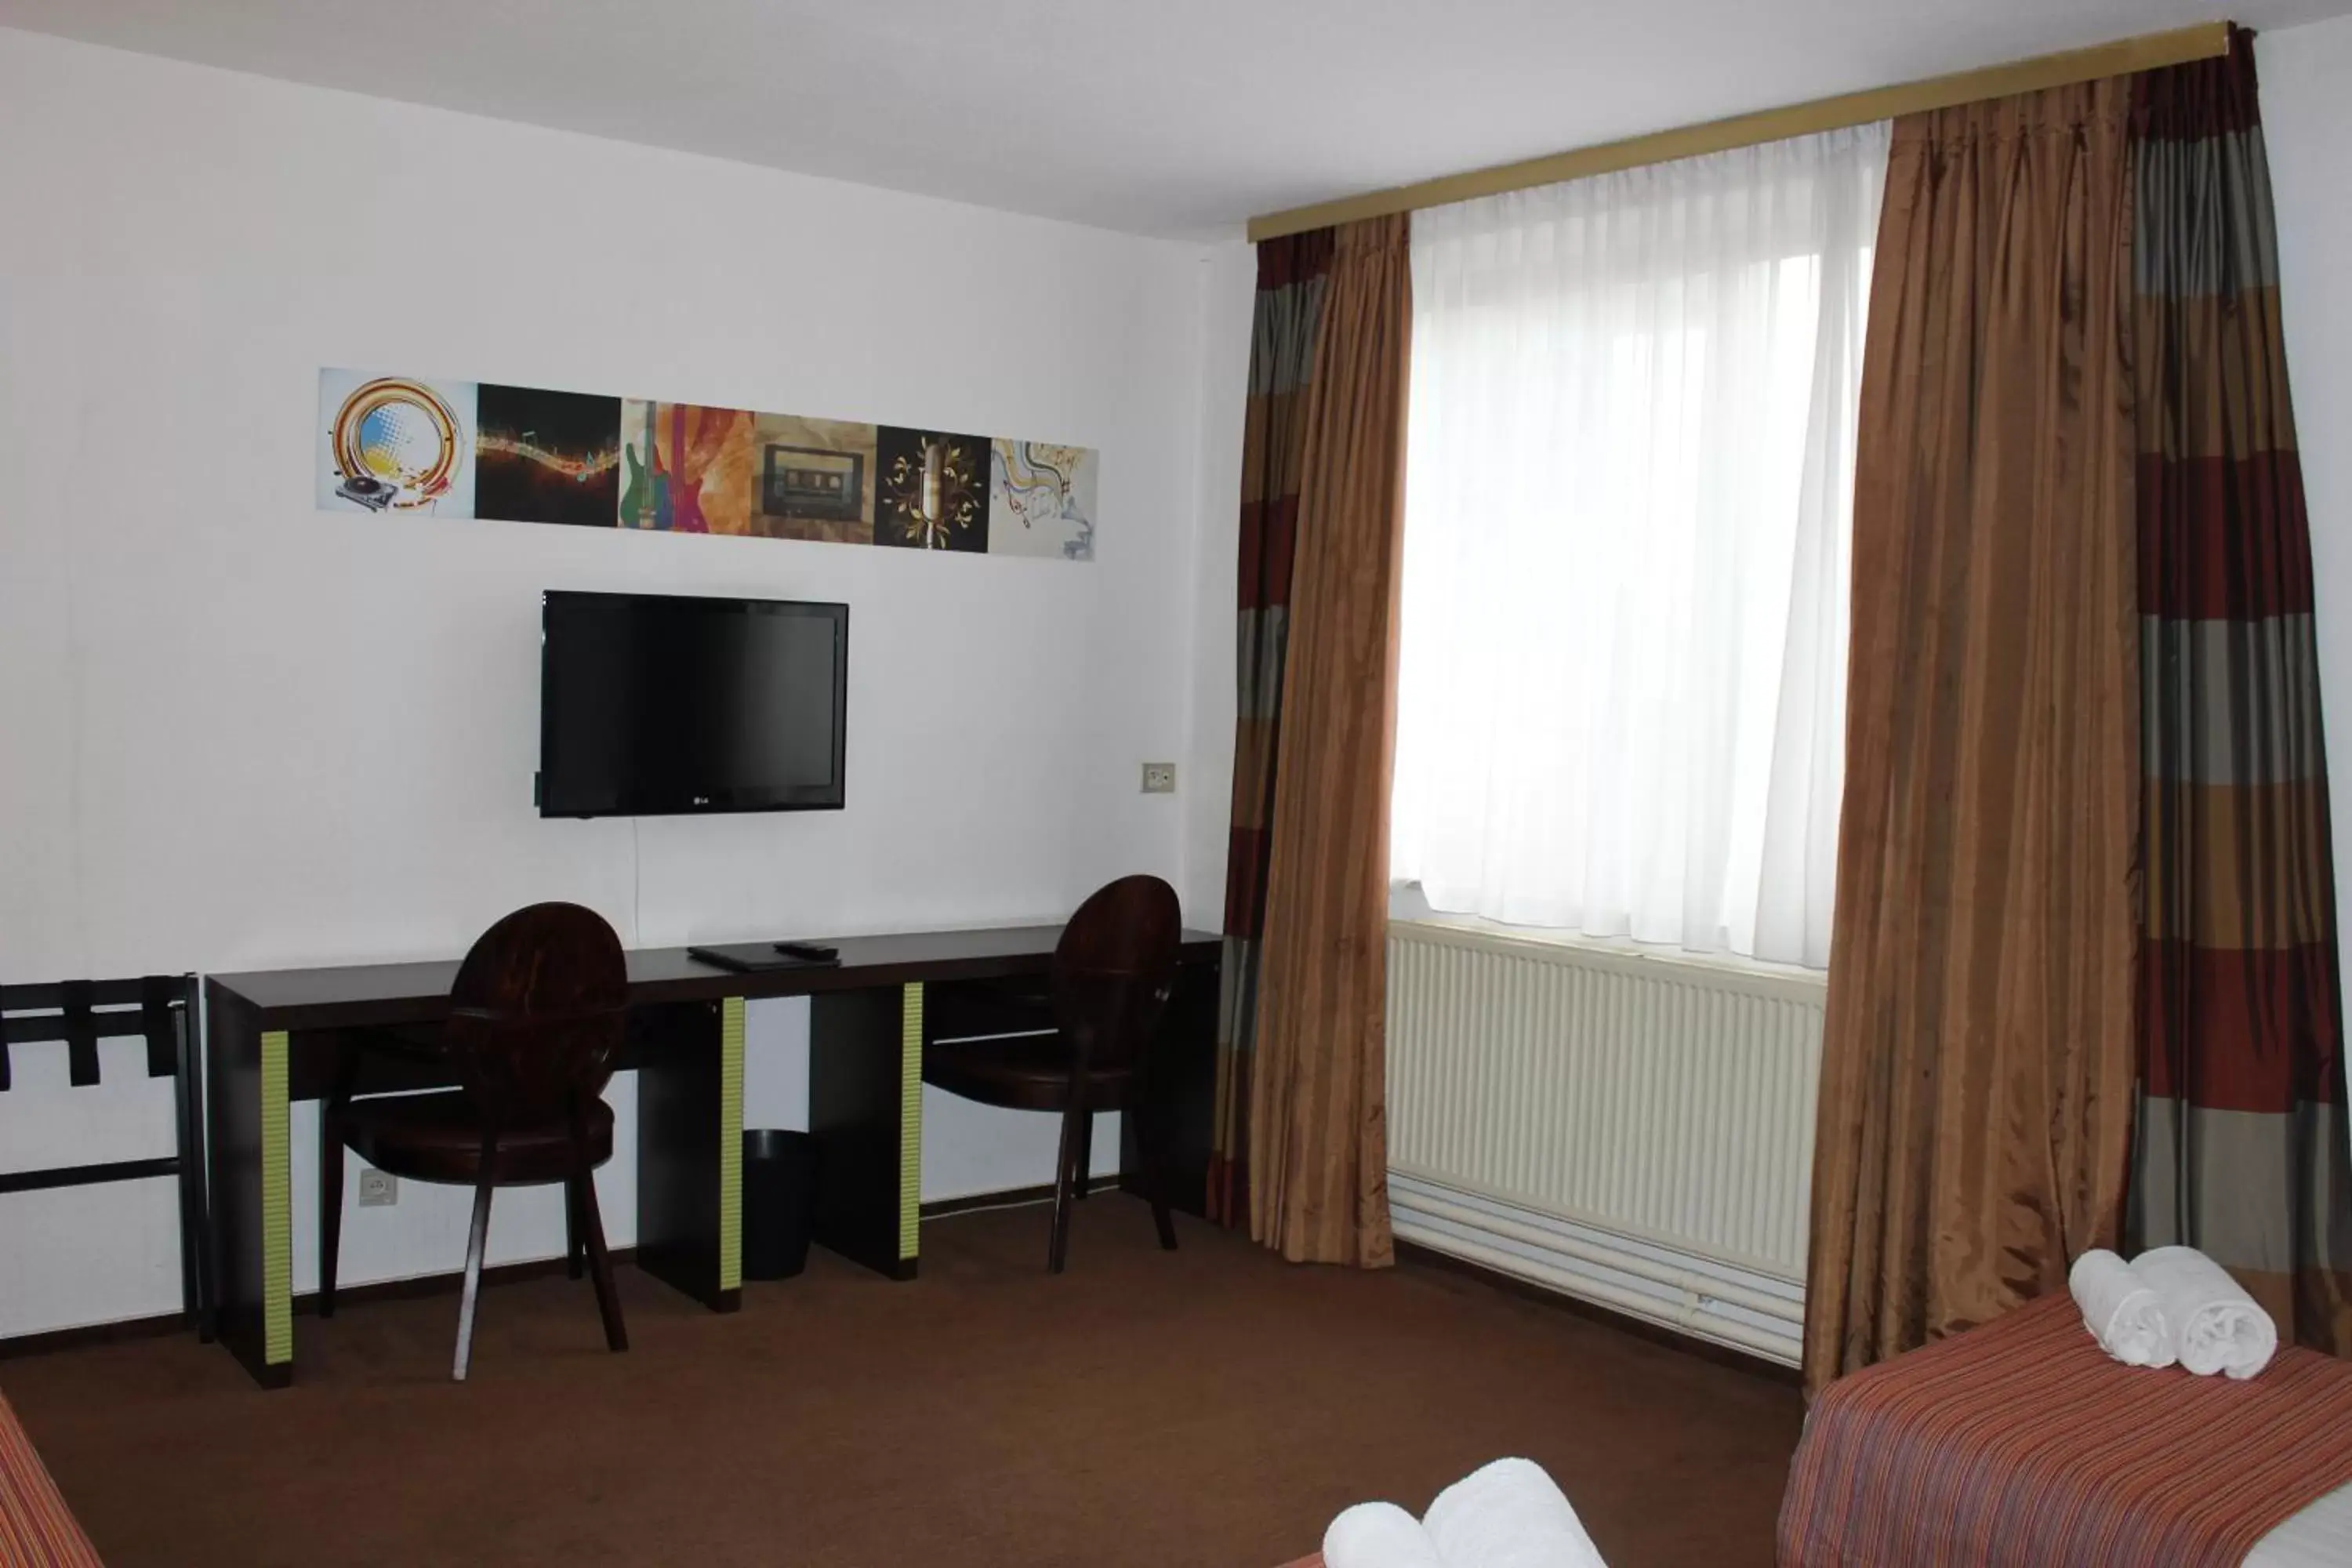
2253, 16, 2352, 1091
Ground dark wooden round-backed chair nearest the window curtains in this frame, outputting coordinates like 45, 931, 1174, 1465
922, 877, 1183, 1274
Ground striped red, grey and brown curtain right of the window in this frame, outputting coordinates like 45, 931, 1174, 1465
2129, 21, 2352, 1354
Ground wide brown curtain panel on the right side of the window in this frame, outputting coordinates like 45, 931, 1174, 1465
1804, 80, 2140, 1387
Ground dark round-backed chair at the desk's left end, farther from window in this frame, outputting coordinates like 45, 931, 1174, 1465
318, 902, 628, 1382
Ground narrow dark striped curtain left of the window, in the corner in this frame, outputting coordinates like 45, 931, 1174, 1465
1209, 228, 1334, 1225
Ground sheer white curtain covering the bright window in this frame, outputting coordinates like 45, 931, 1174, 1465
1390, 125, 1889, 966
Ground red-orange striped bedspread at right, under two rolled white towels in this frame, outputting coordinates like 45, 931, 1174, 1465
1780, 1293, 2352, 1568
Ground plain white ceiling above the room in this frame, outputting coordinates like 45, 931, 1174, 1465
0, 0, 2352, 238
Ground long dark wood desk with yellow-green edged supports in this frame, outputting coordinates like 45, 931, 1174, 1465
205, 926, 1221, 1387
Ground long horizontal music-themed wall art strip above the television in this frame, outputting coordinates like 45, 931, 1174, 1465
318, 369, 1098, 562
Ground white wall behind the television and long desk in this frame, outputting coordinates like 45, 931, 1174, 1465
0, 31, 1247, 1335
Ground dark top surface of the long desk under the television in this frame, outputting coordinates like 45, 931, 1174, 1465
207, 926, 1221, 1029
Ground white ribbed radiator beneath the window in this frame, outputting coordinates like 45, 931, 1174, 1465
1388, 921, 1823, 1366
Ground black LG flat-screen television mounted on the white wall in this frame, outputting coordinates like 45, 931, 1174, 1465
539, 593, 849, 815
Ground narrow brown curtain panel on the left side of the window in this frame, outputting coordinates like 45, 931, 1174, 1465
1249, 216, 1414, 1267
